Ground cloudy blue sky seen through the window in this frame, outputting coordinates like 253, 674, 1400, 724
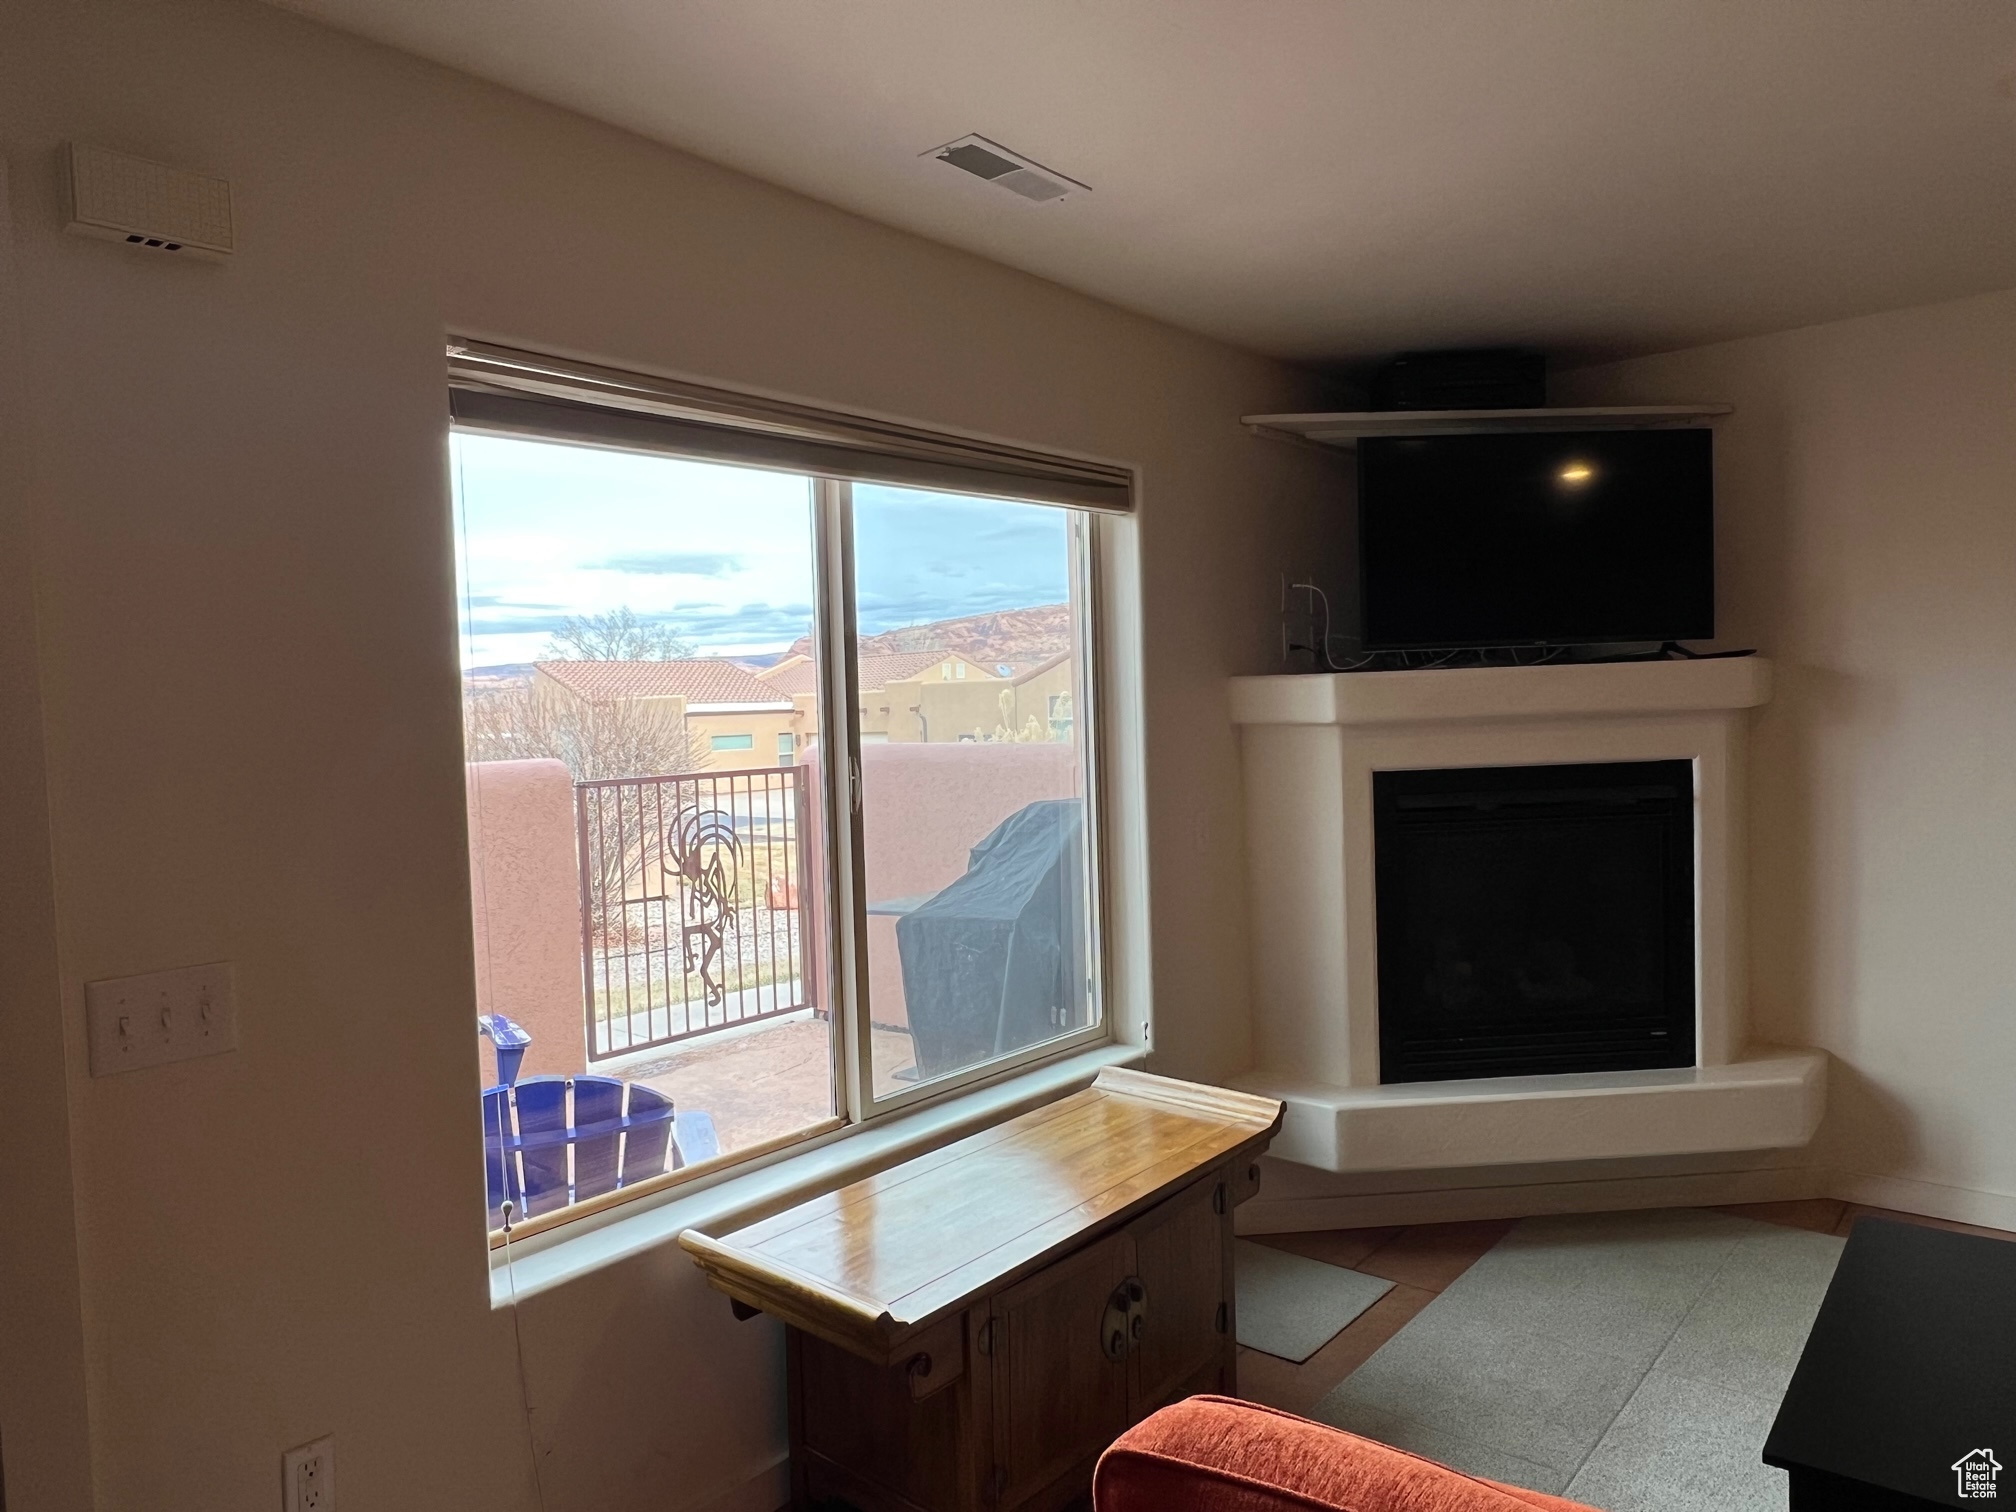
452, 431, 1070, 667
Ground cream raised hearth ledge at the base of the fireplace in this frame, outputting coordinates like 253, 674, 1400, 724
1232, 1046, 1826, 1171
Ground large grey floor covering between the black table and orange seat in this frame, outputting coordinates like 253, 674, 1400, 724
1310, 1208, 1843, 1512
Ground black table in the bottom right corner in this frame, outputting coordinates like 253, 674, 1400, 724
1764, 1218, 2016, 1512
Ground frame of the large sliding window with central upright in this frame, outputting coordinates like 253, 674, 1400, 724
448, 358, 1145, 1248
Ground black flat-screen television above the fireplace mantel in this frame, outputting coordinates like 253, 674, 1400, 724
1359, 429, 1716, 651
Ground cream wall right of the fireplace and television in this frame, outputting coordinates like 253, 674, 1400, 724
1554, 290, 2016, 1226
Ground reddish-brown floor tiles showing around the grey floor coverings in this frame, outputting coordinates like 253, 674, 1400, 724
1240, 1200, 2016, 1435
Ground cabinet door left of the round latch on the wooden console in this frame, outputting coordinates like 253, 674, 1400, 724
990, 1234, 1133, 1508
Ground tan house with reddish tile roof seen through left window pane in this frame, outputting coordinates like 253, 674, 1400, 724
532, 657, 816, 772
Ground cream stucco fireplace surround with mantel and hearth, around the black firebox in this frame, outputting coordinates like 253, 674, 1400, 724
1232, 657, 1824, 1171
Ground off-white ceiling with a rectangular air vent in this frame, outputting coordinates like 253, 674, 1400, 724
264, 0, 2016, 361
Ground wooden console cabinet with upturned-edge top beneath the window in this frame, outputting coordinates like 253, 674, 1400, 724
679, 1068, 1282, 1512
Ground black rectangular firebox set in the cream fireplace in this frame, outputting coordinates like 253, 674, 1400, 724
1373, 762, 1693, 1083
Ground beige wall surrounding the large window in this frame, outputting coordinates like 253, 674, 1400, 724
0, 0, 1335, 1512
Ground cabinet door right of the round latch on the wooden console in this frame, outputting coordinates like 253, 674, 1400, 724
1127, 1173, 1232, 1417
